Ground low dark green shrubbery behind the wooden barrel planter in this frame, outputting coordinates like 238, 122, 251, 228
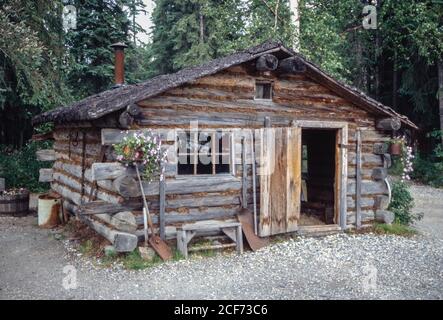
0, 142, 51, 192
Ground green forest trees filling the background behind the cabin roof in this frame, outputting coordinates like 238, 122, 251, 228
0, 0, 443, 190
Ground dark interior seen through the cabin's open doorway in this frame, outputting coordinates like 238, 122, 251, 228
299, 129, 337, 226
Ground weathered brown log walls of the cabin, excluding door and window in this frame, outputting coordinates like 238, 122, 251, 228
52, 66, 389, 236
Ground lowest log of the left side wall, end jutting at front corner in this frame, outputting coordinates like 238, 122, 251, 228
80, 216, 138, 252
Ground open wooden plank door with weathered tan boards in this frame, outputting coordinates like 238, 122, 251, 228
255, 127, 302, 237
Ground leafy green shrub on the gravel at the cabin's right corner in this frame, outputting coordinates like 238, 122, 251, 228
389, 181, 422, 225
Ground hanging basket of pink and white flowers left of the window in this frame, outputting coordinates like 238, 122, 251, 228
114, 130, 166, 182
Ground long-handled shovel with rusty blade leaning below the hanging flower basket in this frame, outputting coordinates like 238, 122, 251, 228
135, 165, 172, 261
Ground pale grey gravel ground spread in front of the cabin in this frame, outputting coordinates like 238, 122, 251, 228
0, 186, 443, 299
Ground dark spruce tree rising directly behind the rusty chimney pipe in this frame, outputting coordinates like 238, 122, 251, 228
66, 0, 142, 98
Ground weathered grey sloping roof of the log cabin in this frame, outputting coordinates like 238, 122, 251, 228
33, 41, 418, 129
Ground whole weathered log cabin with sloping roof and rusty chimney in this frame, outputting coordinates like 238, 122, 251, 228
33, 41, 417, 251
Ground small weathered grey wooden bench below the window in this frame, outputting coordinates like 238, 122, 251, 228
177, 221, 243, 258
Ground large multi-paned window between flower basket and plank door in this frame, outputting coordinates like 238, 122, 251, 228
177, 131, 231, 175
